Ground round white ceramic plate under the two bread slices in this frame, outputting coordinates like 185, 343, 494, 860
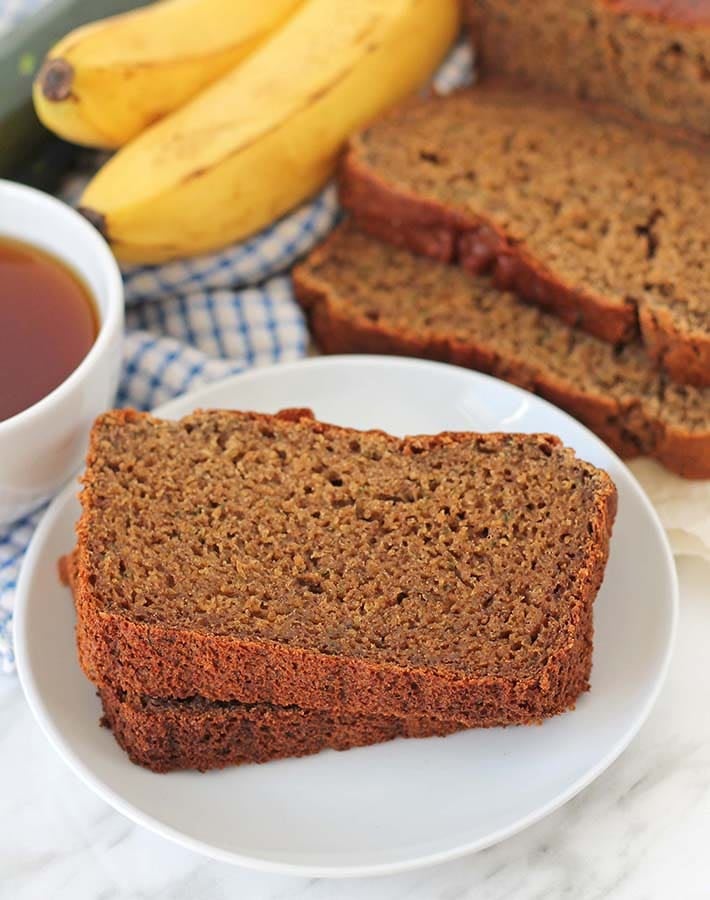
15, 356, 677, 876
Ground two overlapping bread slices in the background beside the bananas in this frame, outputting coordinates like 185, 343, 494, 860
294, 19, 710, 478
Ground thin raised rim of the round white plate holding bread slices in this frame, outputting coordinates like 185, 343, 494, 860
13, 354, 680, 878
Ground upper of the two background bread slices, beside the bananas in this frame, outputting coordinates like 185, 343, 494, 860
340, 84, 710, 386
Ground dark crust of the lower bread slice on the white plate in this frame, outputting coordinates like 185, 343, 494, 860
98, 687, 462, 772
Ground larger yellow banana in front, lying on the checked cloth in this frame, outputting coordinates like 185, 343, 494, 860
81, 0, 459, 263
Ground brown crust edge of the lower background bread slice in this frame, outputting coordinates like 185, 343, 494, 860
293, 235, 710, 479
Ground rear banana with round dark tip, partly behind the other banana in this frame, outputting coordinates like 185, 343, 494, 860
33, 0, 302, 148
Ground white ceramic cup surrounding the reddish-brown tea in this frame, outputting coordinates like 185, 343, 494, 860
0, 179, 123, 524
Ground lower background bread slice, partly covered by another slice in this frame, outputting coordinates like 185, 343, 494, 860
294, 224, 710, 478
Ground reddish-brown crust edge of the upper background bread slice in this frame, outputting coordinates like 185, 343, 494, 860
339, 91, 710, 387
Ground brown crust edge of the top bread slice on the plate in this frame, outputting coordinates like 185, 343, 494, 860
63, 411, 617, 726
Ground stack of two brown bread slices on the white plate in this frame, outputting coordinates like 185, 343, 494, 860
62, 410, 616, 771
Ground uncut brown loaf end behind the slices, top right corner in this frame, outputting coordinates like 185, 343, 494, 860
466, 0, 710, 136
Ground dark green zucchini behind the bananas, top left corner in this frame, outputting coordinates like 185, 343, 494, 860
0, 0, 146, 176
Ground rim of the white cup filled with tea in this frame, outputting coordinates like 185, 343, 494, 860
0, 178, 123, 436
